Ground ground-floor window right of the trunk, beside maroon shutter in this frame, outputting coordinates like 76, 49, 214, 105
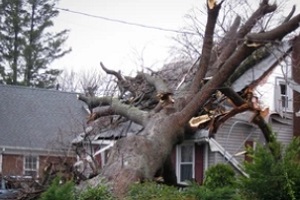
177, 144, 195, 183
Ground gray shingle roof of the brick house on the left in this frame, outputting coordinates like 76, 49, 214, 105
0, 85, 87, 152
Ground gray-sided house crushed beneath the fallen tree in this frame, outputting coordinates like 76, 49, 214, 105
73, 42, 295, 184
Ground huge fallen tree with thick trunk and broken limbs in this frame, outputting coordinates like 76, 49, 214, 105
78, 0, 300, 198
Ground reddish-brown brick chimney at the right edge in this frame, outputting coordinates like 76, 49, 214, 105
292, 35, 300, 137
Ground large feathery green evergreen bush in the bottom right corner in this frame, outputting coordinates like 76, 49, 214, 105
240, 138, 300, 200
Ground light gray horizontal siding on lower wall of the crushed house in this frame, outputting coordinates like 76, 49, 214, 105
207, 113, 293, 172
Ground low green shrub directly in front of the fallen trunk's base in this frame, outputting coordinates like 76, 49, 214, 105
78, 186, 115, 200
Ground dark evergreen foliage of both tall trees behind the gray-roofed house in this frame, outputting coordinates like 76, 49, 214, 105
0, 0, 70, 88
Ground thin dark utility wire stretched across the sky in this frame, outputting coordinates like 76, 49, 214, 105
55, 7, 196, 35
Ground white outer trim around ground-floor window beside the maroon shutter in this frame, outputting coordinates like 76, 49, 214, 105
176, 142, 195, 185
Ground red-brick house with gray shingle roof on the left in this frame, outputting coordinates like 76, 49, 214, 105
0, 85, 87, 178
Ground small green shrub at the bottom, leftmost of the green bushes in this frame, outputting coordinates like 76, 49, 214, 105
40, 177, 75, 200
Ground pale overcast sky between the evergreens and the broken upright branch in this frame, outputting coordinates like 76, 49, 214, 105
52, 0, 300, 73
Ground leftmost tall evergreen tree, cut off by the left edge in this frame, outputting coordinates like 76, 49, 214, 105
0, 0, 26, 84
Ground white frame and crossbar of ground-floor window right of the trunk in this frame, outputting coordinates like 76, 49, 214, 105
176, 142, 195, 185
